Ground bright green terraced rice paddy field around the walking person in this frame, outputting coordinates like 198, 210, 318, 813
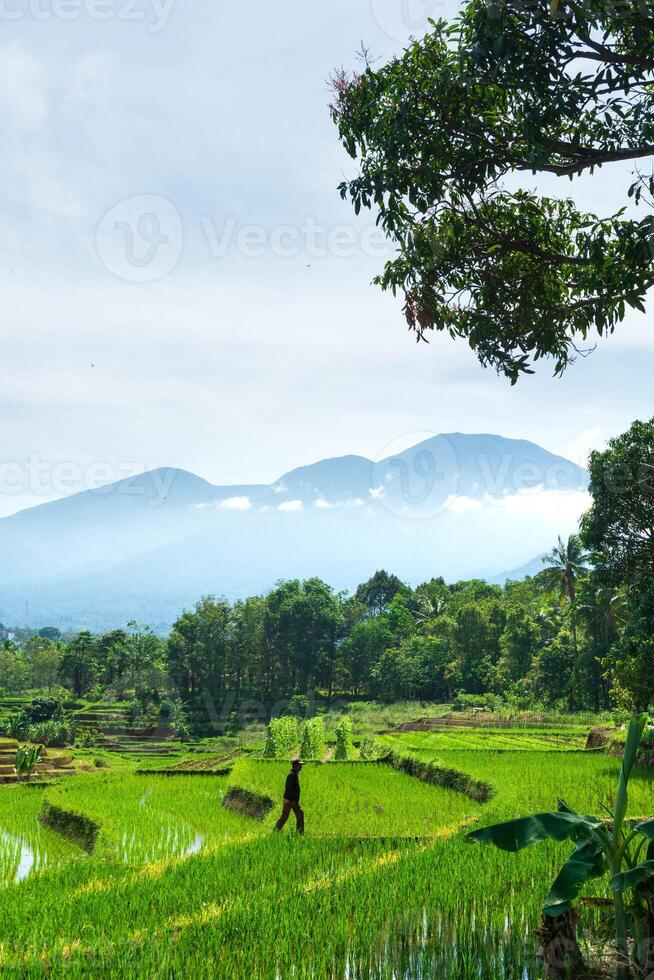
0, 732, 654, 980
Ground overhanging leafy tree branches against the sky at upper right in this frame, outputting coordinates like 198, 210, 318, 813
332, 0, 654, 383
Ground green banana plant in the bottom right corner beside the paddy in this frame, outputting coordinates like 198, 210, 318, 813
468, 713, 654, 980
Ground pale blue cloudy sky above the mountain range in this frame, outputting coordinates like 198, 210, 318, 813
0, 0, 654, 516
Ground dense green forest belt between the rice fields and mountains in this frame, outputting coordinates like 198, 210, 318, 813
0, 421, 654, 710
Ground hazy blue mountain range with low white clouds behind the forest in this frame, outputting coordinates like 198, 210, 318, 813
0, 433, 587, 630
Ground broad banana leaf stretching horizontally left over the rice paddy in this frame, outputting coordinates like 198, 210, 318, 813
467, 808, 602, 851
